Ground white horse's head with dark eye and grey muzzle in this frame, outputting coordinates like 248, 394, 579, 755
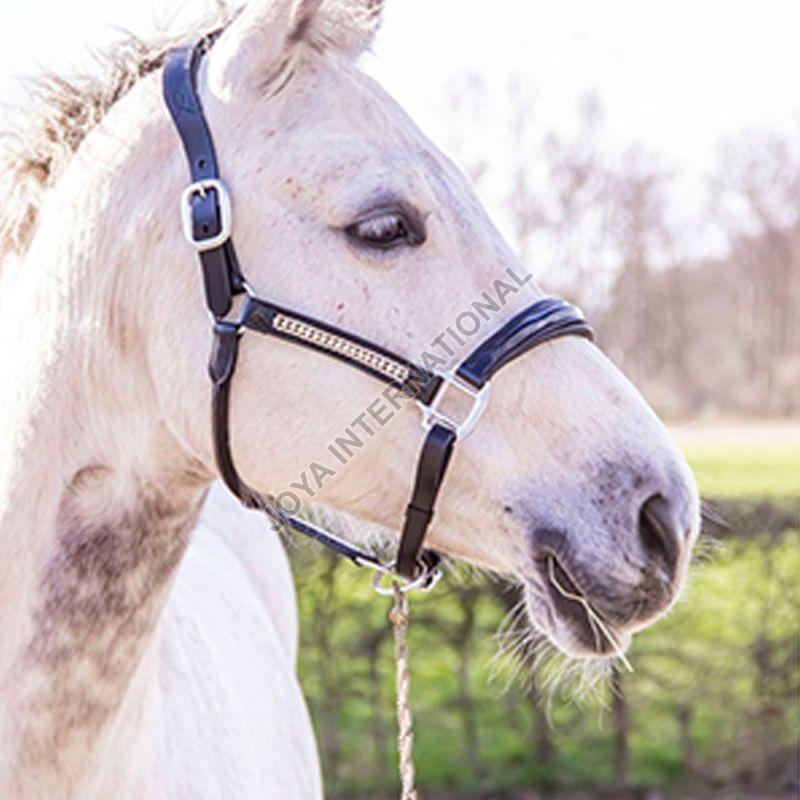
142, 0, 698, 655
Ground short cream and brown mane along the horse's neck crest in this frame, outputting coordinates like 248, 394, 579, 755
0, 6, 234, 263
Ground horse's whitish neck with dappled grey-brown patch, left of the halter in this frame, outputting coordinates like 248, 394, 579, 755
0, 73, 210, 798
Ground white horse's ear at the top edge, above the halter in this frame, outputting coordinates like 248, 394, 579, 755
209, 0, 383, 94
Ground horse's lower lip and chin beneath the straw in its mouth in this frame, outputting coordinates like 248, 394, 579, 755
524, 580, 633, 659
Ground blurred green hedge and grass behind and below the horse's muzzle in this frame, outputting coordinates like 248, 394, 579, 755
293, 440, 800, 798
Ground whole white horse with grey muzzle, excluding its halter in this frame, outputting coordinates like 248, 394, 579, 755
0, 0, 698, 800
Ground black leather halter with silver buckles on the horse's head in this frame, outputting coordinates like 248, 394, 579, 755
163, 38, 592, 584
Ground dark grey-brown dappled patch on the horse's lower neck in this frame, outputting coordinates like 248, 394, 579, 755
18, 484, 199, 768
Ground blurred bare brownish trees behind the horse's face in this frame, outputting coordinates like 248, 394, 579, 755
440, 76, 800, 416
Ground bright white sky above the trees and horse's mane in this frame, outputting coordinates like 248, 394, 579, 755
0, 0, 800, 250
